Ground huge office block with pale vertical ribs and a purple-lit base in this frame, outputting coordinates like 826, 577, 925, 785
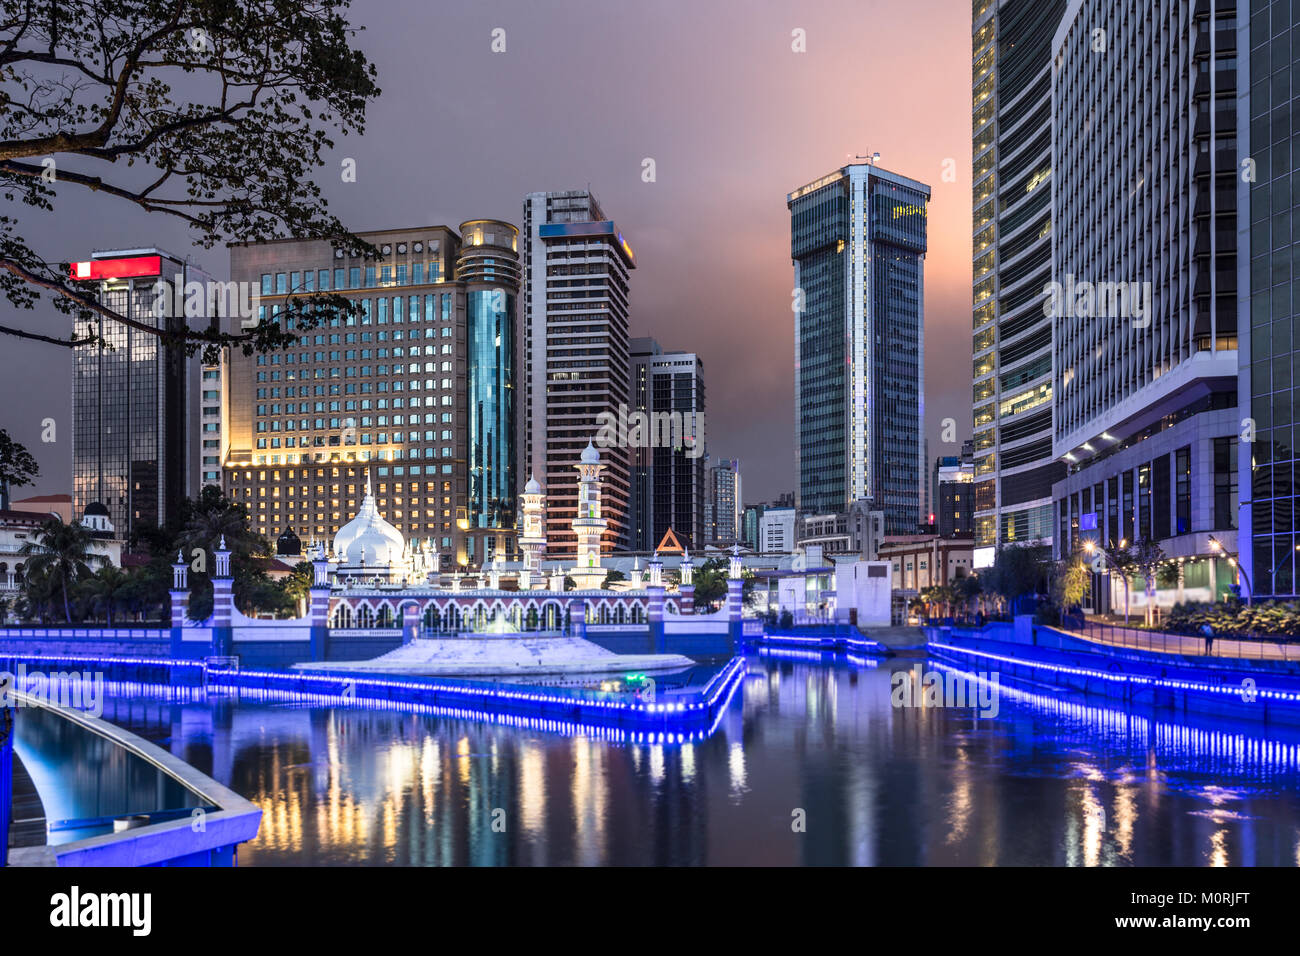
1049, 0, 1237, 600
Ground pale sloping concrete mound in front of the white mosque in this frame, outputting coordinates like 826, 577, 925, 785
294, 636, 694, 678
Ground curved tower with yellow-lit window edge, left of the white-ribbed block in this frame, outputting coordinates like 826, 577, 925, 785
971, 0, 1066, 566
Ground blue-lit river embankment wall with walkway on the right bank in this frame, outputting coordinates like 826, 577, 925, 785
926, 615, 1300, 726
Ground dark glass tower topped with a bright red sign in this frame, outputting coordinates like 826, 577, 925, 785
72, 247, 215, 540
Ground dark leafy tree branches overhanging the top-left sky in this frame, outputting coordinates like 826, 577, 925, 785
0, 0, 380, 360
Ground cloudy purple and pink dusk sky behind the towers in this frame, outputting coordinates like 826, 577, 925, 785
0, 0, 971, 503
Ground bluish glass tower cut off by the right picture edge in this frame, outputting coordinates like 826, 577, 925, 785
1237, 0, 1300, 600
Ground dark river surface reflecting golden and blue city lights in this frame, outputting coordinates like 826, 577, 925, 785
78, 656, 1300, 866
